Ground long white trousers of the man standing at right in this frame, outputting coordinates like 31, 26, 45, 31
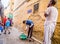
44, 23, 55, 44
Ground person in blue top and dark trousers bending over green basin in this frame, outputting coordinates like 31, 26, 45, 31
23, 20, 34, 41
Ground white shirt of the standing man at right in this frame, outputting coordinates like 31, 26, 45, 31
45, 6, 58, 24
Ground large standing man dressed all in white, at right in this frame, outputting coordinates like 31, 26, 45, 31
44, 0, 58, 44
